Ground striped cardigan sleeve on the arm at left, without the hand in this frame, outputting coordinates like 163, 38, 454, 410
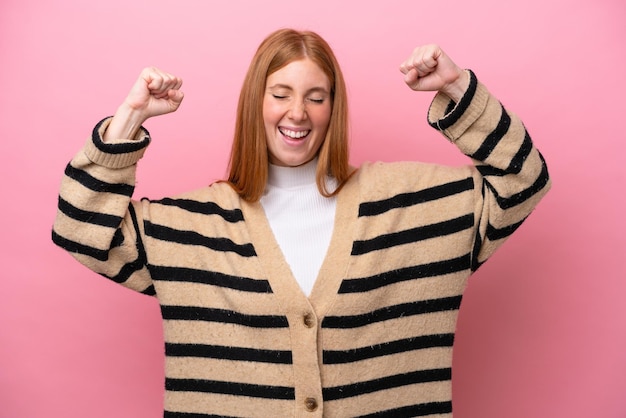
52, 118, 154, 295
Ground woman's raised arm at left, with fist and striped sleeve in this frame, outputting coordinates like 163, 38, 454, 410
52, 68, 183, 294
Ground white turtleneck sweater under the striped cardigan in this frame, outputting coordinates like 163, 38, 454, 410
261, 159, 337, 296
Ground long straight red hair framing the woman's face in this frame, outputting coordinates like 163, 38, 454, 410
228, 29, 351, 202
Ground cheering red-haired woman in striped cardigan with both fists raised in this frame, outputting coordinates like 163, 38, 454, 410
53, 30, 550, 417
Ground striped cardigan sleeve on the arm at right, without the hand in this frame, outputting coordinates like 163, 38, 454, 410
428, 71, 551, 270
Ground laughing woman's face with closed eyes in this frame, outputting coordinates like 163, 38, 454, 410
263, 58, 332, 167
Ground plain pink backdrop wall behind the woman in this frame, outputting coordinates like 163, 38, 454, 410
0, 0, 626, 418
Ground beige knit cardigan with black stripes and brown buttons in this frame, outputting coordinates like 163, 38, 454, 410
52, 73, 550, 418
